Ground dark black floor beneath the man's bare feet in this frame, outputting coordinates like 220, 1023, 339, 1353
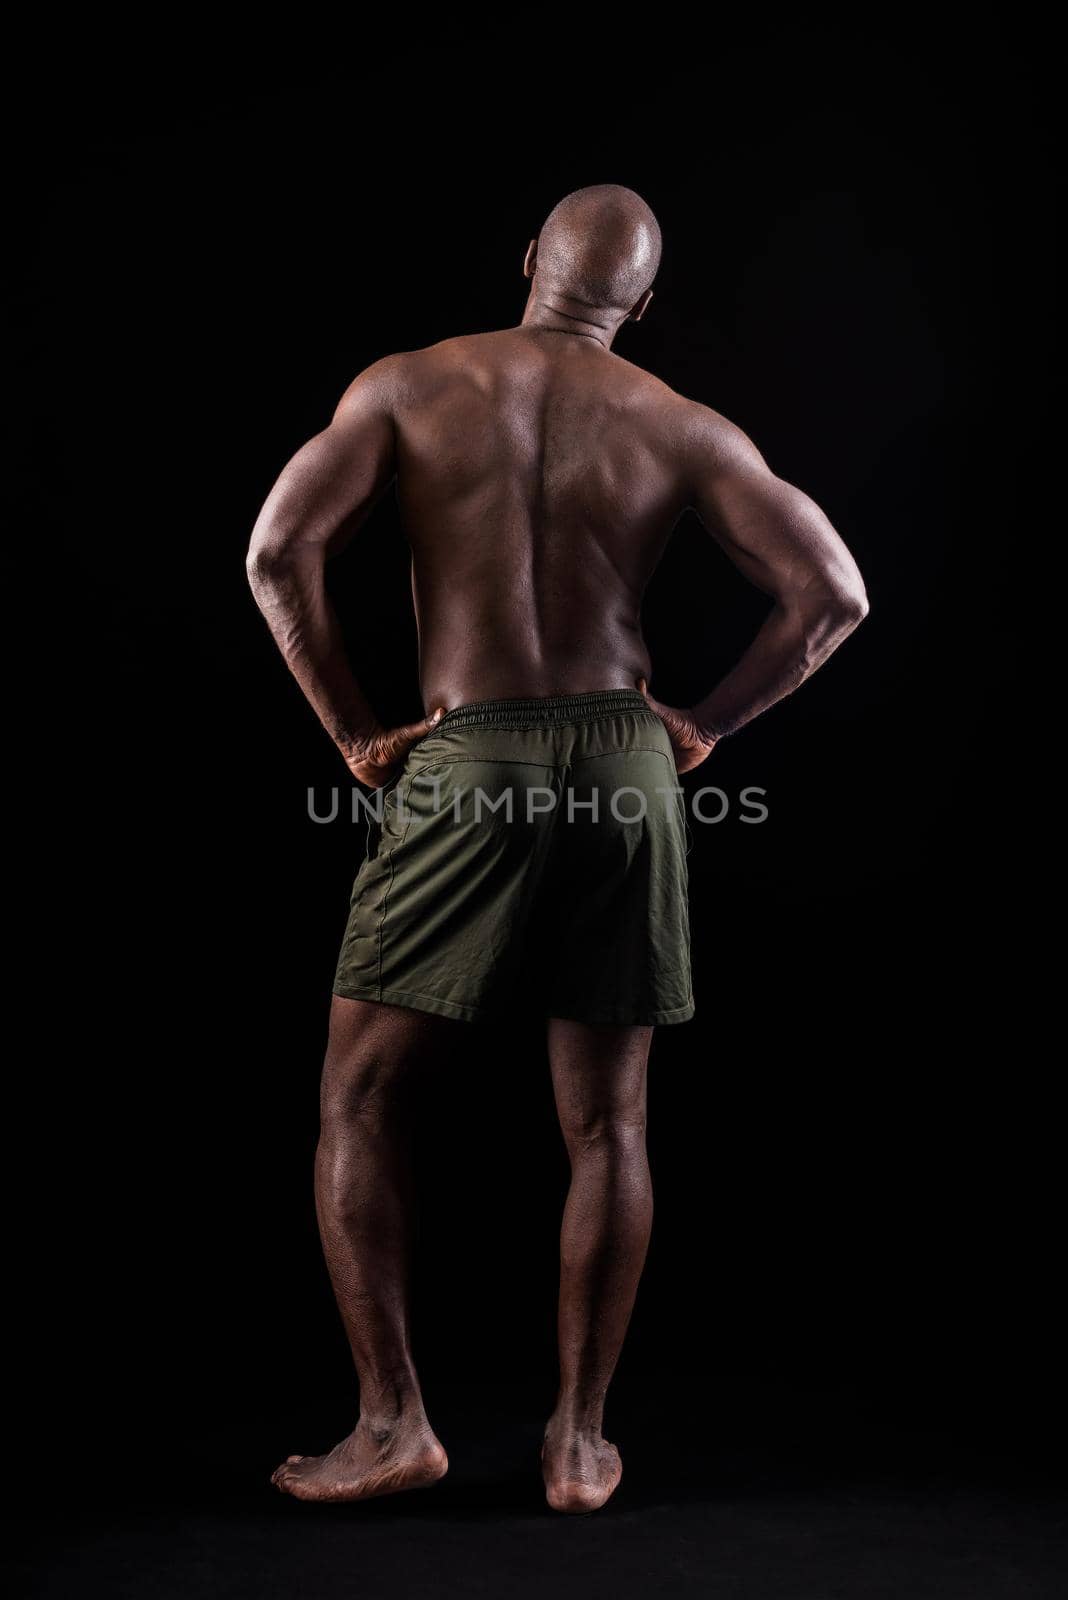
8, 1397, 1068, 1600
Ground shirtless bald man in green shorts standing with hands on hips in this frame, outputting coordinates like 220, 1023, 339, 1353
248, 184, 868, 1512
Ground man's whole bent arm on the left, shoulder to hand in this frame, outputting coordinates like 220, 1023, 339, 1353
246, 355, 436, 787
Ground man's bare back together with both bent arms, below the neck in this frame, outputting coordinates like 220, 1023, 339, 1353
246, 323, 867, 758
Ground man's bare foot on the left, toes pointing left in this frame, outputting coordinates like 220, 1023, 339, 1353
270, 1418, 449, 1501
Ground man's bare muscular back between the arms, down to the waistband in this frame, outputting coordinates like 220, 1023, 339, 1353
392, 328, 697, 706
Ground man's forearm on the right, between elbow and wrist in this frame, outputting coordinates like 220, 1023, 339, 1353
692, 590, 868, 738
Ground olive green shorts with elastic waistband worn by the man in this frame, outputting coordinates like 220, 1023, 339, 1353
334, 690, 694, 1024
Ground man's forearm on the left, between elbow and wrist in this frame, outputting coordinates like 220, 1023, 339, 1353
248, 549, 377, 760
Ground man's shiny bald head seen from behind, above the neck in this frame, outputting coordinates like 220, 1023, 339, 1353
537, 184, 660, 315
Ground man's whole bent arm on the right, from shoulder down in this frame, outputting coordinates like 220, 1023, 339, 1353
652, 403, 868, 770
